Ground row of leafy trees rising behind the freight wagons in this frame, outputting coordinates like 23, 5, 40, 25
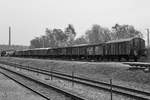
30, 24, 143, 48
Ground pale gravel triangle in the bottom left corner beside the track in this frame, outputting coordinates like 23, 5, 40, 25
0, 69, 45, 100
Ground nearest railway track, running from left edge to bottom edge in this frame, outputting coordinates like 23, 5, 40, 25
0, 63, 88, 100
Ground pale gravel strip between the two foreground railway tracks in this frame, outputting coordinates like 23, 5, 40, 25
2, 63, 135, 100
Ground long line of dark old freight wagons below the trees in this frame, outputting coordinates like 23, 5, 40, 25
7, 37, 146, 61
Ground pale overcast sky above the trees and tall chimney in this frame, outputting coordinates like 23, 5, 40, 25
0, 0, 150, 45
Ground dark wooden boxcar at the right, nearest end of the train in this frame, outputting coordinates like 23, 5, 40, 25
104, 37, 145, 61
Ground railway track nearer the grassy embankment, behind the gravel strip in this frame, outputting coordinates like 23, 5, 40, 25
0, 62, 150, 100
